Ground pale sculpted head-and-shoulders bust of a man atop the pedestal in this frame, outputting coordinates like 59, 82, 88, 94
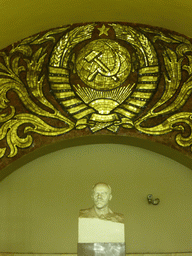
79, 182, 124, 223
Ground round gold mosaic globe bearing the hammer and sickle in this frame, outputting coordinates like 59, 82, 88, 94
76, 39, 131, 90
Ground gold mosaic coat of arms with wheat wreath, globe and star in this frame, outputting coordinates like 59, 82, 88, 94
49, 24, 159, 132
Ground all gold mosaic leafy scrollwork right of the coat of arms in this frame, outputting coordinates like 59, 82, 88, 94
135, 31, 192, 148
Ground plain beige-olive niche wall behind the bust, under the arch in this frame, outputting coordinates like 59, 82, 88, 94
0, 144, 192, 253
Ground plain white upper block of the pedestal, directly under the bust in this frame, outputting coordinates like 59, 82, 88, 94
78, 218, 125, 243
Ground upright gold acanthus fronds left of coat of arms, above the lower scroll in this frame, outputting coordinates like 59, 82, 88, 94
0, 48, 73, 126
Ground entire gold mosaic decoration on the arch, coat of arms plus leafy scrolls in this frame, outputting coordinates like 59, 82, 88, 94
0, 23, 192, 157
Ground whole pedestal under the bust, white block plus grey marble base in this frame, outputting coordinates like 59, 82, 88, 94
77, 218, 125, 256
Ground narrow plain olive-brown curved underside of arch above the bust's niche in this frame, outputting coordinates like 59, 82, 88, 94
0, 135, 192, 180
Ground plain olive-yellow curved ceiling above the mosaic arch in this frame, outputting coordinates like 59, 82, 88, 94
0, 0, 192, 49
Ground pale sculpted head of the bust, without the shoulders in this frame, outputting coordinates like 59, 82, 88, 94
92, 184, 112, 209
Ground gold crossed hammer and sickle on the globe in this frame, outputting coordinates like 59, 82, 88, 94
85, 50, 120, 81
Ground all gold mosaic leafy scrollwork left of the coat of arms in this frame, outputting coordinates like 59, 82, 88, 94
0, 28, 74, 157
